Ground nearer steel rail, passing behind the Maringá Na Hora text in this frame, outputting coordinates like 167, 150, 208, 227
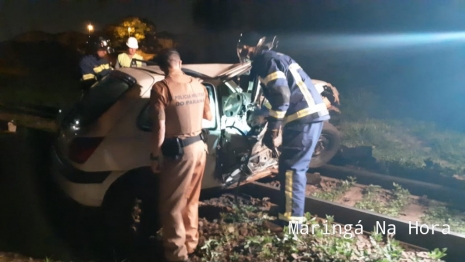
241, 182, 465, 261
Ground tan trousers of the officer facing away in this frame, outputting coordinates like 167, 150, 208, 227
160, 141, 206, 261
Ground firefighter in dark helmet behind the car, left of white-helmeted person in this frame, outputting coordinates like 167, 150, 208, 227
79, 37, 113, 89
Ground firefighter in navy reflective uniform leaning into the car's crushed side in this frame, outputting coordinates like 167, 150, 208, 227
237, 32, 330, 231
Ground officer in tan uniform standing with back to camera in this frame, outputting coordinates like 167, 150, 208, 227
150, 49, 212, 261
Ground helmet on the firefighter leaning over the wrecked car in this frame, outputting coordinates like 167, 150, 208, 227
236, 31, 278, 62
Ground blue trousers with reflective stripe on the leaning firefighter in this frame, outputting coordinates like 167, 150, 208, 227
278, 122, 323, 226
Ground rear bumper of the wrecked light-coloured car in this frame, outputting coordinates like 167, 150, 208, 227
52, 145, 124, 207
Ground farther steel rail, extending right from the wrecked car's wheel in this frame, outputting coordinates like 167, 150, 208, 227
311, 165, 465, 209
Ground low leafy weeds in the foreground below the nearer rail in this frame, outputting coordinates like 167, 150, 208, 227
196, 206, 445, 261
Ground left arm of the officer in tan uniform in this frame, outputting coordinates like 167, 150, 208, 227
150, 84, 166, 157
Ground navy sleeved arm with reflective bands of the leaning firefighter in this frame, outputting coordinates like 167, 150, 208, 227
260, 60, 290, 131
